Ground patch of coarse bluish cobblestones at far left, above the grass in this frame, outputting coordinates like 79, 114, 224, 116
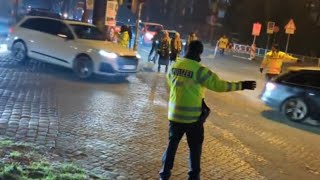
0, 54, 58, 147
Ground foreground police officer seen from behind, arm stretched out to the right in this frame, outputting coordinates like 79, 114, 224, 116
160, 40, 256, 180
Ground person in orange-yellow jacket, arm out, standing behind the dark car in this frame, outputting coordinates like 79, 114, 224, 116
260, 44, 300, 81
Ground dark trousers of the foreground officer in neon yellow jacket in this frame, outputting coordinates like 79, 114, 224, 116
160, 122, 204, 180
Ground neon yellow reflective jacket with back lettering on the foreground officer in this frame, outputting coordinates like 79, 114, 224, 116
167, 58, 242, 123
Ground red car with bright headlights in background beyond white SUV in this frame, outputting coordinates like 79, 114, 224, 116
140, 22, 164, 45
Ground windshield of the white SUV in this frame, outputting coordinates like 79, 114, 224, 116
71, 24, 106, 41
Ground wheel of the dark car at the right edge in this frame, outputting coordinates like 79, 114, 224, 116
282, 98, 310, 122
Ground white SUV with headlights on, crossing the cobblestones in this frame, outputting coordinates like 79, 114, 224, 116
7, 16, 140, 78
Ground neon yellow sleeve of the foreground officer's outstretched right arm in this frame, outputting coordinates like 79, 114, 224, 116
196, 66, 242, 92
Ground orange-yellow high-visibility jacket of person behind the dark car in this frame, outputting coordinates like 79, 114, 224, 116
260, 51, 298, 74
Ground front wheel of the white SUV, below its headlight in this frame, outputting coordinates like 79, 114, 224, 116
73, 56, 93, 79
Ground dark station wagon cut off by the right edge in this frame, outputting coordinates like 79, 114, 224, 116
261, 67, 320, 122
